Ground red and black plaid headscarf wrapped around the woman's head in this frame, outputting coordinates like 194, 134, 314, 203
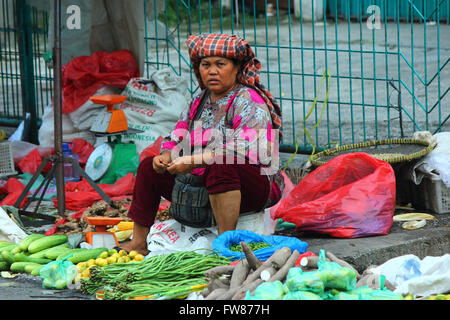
186, 34, 282, 136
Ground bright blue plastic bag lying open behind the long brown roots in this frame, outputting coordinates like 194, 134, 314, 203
212, 230, 308, 261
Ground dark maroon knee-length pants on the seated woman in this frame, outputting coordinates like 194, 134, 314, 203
128, 157, 270, 228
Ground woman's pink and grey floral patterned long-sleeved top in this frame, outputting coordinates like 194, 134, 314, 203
162, 84, 284, 204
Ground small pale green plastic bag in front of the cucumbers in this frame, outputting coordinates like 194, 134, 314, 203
39, 254, 78, 290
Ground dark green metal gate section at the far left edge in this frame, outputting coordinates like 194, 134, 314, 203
0, 0, 53, 143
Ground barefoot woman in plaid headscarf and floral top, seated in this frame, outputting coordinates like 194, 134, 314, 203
123, 34, 284, 254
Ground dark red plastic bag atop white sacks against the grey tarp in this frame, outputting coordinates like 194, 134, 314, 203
62, 50, 139, 113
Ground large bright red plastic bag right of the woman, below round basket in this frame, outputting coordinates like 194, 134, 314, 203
275, 152, 396, 238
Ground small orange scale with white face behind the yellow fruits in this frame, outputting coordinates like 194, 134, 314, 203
83, 216, 122, 249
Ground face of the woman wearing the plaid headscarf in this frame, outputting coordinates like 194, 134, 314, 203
199, 57, 239, 98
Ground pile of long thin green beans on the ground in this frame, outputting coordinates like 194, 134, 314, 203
80, 251, 231, 300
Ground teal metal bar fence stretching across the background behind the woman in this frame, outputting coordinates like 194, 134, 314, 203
0, 0, 450, 153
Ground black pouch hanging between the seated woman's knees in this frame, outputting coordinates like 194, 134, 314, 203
169, 173, 216, 228
